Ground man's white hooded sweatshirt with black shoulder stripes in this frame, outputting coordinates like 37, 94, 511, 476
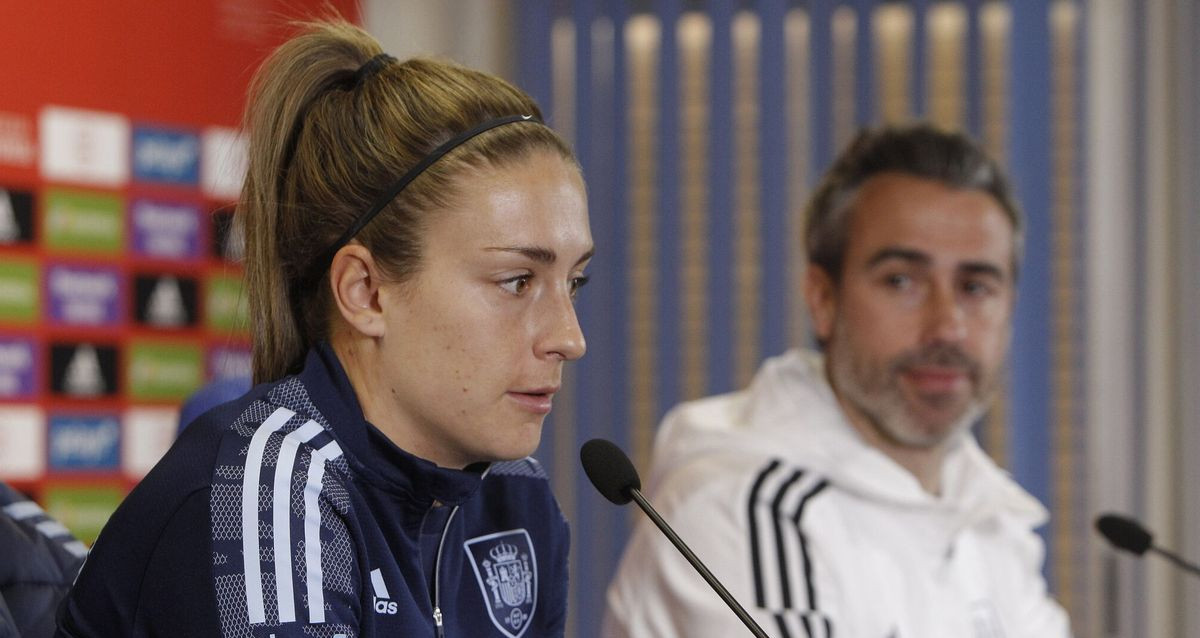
602, 350, 1069, 638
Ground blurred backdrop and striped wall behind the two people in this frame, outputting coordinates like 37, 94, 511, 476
0, 0, 1200, 638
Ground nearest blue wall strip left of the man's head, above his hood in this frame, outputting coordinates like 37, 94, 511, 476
758, 0, 798, 356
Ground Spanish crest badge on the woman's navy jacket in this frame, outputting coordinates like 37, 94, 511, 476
462, 529, 538, 638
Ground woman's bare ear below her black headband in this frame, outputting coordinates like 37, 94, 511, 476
329, 243, 384, 337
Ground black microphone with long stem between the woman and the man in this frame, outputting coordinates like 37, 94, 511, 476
580, 439, 769, 638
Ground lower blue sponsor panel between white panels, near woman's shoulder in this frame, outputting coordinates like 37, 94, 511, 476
49, 415, 121, 471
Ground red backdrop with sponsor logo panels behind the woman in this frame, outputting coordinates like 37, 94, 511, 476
0, 0, 359, 540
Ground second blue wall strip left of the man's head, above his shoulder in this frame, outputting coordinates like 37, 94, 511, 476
708, 1, 736, 393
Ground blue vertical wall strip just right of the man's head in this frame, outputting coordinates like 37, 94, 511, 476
1008, 0, 1054, 578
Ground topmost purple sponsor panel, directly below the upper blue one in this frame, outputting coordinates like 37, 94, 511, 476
130, 199, 202, 259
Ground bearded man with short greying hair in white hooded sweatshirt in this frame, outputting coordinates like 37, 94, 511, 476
604, 125, 1069, 638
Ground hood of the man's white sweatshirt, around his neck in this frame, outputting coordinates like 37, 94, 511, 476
654, 350, 1048, 529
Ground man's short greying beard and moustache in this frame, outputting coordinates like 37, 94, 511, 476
827, 318, 1000, 450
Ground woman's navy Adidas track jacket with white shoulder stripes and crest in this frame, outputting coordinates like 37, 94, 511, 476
58, 344, 569, 638
